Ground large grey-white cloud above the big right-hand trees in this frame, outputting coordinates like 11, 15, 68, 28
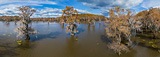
78, 0, 143, 16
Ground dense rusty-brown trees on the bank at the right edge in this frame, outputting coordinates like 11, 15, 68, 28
135, 8, 160, 38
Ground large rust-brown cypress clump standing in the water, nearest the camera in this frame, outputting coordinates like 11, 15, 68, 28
106, 7, 140, 54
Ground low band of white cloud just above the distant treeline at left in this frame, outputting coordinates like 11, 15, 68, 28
0, 4, 90, 18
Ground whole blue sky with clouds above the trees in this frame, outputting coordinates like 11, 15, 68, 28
0, 0, 160, 17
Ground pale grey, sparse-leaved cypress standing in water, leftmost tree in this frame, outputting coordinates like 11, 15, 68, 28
16, 6, 36, 42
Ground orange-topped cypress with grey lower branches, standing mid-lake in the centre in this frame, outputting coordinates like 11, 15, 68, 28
60, 6, 78, 35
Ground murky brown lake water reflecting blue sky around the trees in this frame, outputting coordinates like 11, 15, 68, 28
0, 22, 160, 57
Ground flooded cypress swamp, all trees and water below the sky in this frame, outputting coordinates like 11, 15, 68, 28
0, 1, 160, 57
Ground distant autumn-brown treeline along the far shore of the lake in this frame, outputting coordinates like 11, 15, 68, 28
0, 14, 106, 22
